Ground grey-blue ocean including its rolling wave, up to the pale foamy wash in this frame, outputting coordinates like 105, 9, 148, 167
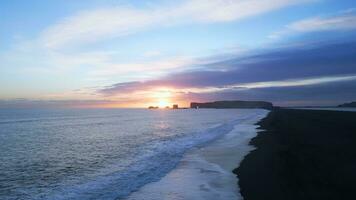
0, 109, 267, 200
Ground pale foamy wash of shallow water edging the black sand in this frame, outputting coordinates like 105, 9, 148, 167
125, 110, 268, 200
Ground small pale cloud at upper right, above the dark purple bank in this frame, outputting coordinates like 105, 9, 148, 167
269, 11, 356, 38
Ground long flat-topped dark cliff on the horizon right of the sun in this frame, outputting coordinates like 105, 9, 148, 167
190, 101, 273, 110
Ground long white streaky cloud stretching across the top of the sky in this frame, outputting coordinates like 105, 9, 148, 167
40, 0, 310, 49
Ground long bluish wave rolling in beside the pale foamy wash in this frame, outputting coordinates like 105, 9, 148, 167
42, 113, 262, 199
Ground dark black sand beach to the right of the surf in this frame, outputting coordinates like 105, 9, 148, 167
234, 109, 356, 200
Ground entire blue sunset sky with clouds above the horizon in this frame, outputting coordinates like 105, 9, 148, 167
0, 0, 356, 108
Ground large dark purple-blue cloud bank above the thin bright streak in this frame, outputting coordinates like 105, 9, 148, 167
101, 42, 356, 92
